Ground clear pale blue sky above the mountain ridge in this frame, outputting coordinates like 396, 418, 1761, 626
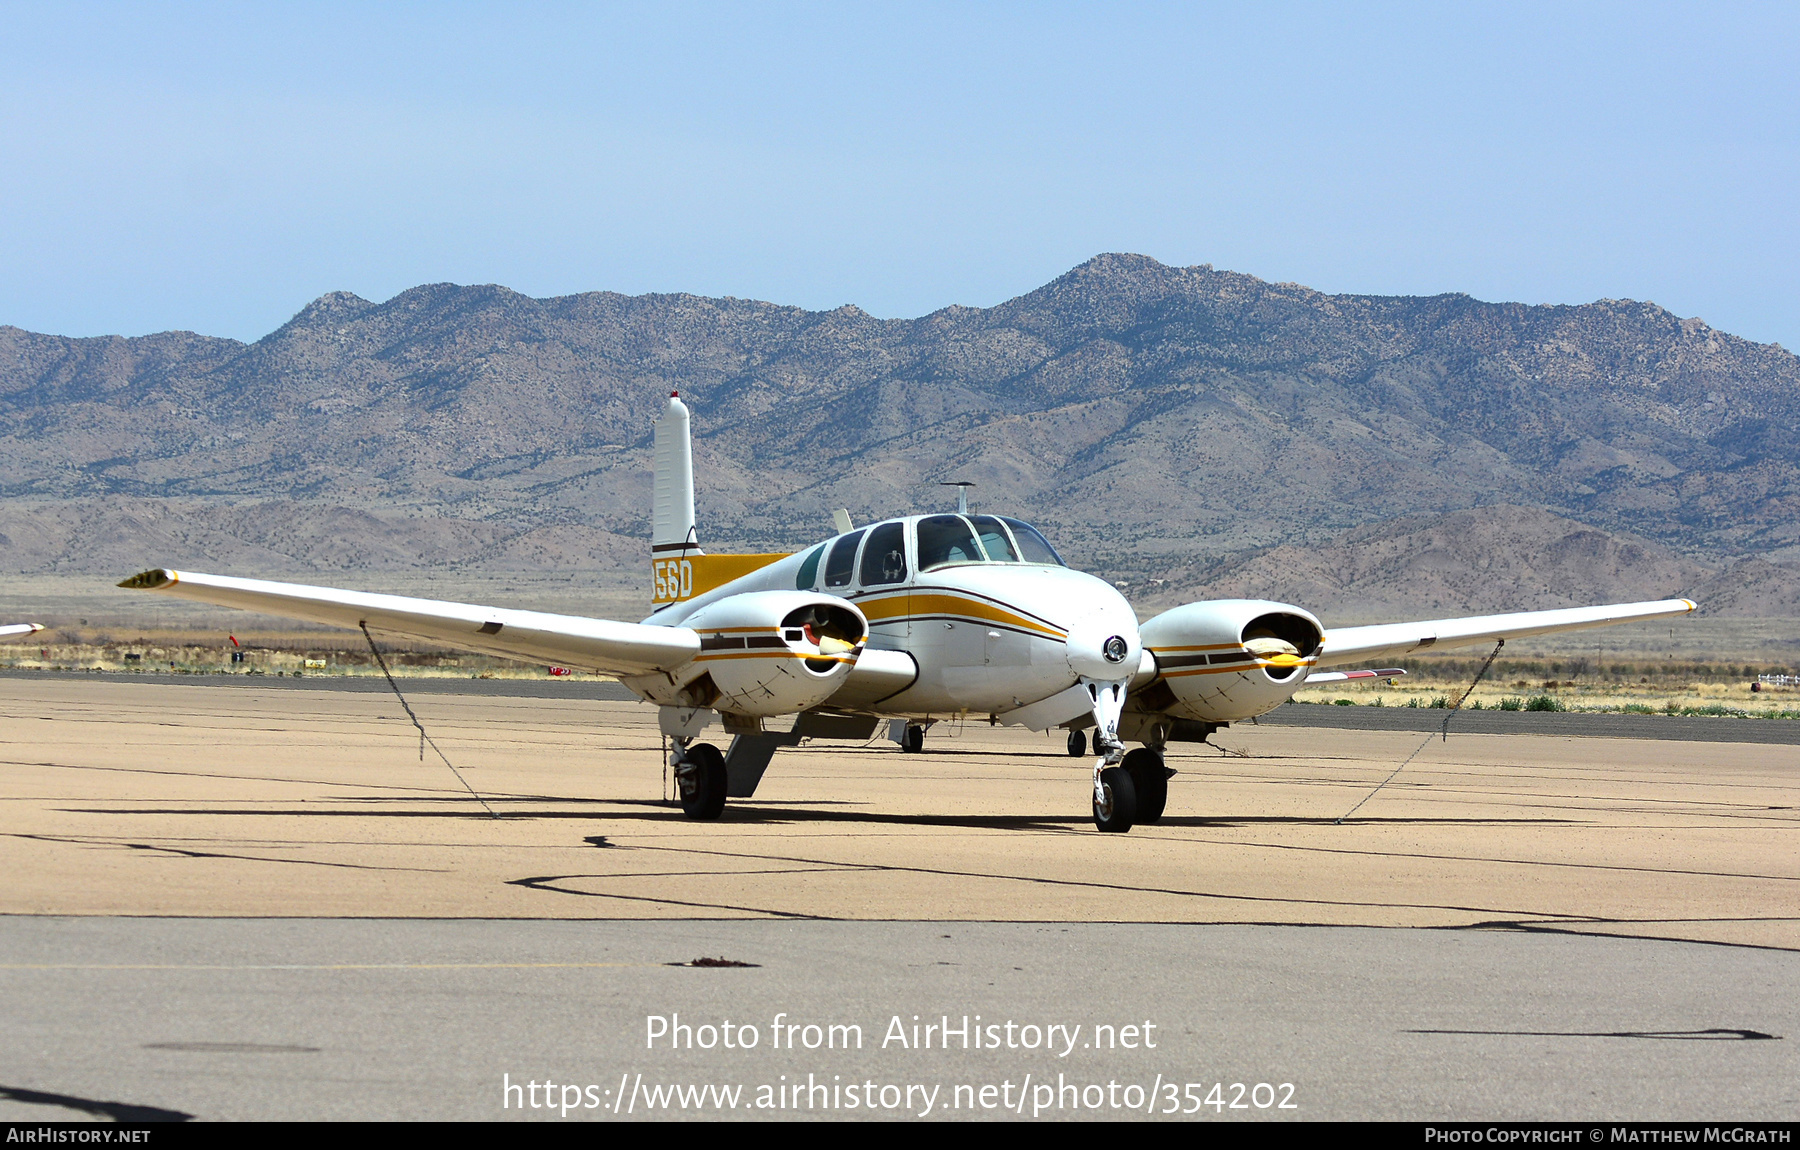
0, 4, 1800, 347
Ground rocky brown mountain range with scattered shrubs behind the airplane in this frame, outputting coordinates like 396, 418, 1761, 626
0, 256, 1800, 606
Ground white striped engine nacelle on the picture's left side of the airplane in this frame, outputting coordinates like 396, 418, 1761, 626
646, 590, 869, 718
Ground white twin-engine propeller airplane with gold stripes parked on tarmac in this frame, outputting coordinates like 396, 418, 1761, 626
121, 394, 1696, 831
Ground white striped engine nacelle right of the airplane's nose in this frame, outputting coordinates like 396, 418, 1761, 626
1134, 599, 1325, 723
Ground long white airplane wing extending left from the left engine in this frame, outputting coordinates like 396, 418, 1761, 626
119, 569, 700, 677
